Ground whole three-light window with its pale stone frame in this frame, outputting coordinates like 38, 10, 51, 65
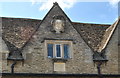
46, 40, 72, 59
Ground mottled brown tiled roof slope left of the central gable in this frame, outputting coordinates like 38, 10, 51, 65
2, 17, 41, 48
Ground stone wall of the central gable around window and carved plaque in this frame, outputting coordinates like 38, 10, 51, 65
3, 3, 97, 74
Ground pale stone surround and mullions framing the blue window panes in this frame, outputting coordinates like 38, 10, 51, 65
45, 40, 73, 59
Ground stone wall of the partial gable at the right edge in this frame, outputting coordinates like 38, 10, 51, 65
102, 28, 119, 74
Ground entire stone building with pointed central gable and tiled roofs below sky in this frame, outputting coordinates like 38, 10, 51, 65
0, 3, 120, 78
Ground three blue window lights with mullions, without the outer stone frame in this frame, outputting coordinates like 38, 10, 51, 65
47, 43, 70, 59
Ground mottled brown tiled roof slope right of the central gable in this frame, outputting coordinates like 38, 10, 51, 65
73, 23, 110, 51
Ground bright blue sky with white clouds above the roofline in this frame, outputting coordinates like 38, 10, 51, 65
0, 0, 119, 24
